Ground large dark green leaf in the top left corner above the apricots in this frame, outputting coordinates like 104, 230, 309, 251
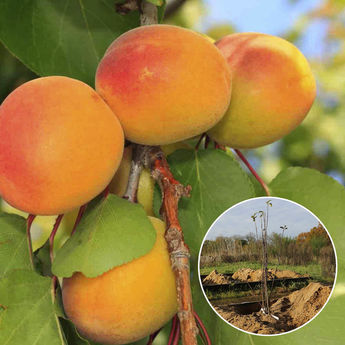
0, 0, 139, 86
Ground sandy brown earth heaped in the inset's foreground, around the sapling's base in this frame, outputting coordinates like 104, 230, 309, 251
215, 283, 331, 334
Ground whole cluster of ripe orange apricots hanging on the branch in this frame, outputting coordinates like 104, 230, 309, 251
0, 25, 316, 344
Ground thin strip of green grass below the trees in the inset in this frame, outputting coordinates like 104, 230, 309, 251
200, 261, 333, 283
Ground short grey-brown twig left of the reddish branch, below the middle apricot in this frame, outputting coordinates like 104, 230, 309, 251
123, 144, 146, 203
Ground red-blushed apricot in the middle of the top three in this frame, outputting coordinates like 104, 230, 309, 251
96, 24, 231, 145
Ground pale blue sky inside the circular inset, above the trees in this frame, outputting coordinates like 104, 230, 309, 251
206, 197, 319, 240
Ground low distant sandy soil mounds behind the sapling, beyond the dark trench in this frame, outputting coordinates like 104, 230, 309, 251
232, 268, 309, 282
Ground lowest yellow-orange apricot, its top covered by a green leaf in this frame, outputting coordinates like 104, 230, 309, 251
62, 217, 177, 344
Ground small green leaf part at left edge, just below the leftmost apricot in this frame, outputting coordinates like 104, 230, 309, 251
0, 213, 31, 277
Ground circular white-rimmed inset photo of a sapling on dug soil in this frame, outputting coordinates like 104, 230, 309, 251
199, 197, 337, 335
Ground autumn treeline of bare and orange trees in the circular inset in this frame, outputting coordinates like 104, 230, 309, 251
200, 224, 335, 276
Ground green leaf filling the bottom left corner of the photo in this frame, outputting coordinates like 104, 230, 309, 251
0, 270, 65, 345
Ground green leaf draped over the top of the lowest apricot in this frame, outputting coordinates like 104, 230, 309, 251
52, 194, 156, 277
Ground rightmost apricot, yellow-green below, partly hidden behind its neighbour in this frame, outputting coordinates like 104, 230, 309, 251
208, 33, 316, 148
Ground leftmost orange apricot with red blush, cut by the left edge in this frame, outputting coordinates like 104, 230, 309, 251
0, 76, 124, 215
